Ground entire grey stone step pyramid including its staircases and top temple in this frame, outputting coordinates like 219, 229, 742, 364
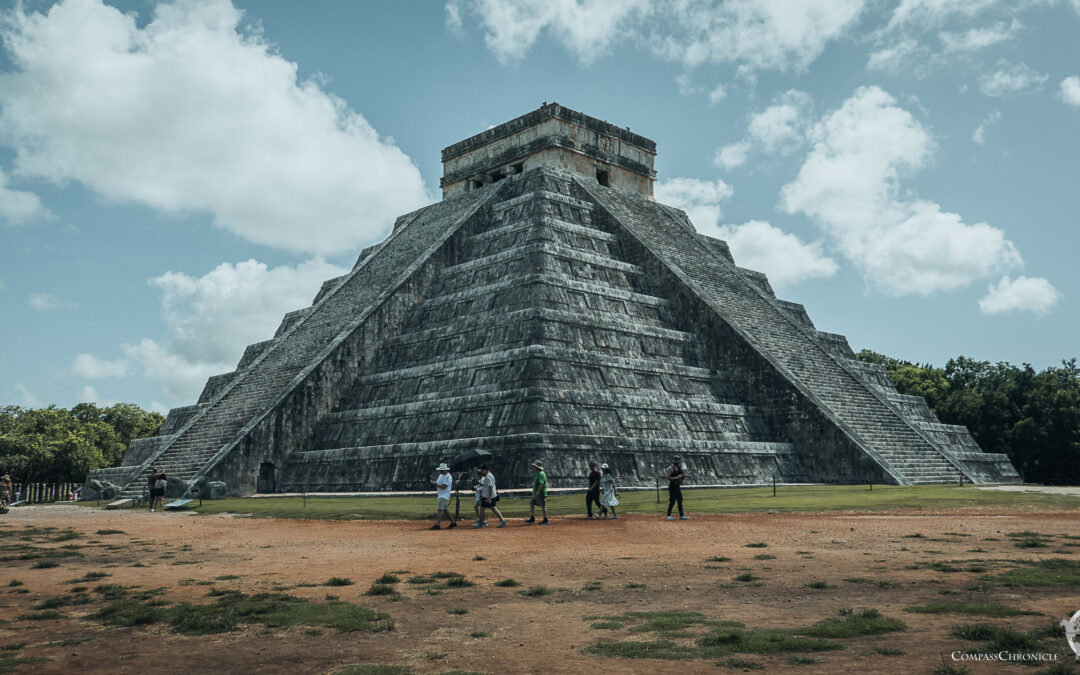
90, 104, 1018, 495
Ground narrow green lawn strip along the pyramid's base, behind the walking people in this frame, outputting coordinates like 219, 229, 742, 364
174, 485, 1080, 520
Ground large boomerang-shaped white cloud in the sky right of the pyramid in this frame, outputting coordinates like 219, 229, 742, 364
780, 86, 1022, 295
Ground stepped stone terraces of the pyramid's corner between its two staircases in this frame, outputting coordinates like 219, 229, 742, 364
289, 166, 792, 489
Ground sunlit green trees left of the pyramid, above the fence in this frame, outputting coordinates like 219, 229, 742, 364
0, 403, 165, 483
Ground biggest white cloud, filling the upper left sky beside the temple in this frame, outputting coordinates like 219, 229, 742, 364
0, 0, 429, 254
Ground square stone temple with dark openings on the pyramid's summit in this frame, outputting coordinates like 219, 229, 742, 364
440, 103, 657, 199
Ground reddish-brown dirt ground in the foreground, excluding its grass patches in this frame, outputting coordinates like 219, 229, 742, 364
0, 505, 1080, 674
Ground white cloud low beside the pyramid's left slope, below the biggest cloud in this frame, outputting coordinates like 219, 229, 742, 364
98, 254, 348, 403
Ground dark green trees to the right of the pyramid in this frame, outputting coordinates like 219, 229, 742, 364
858, 349, 1080, 484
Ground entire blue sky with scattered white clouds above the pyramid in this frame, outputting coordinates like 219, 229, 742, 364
0, 0, 1080, 410
